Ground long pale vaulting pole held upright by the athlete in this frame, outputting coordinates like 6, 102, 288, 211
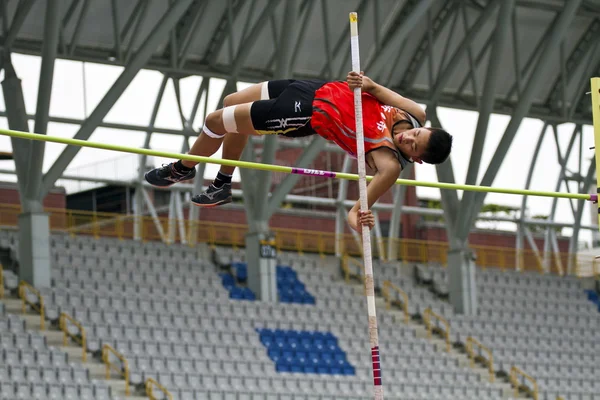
350, 12, 383, 400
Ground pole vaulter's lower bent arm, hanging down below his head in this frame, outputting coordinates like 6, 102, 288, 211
348, 149, 402, 232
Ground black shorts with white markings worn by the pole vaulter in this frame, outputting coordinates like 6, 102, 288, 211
250, 79, 327, 137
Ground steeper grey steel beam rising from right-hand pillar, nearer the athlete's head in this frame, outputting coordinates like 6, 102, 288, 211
455, 0, 515, 244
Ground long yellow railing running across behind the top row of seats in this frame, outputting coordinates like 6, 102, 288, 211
0, 204, 584, 272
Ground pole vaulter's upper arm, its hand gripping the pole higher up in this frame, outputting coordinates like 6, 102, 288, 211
347, 71, 427, 126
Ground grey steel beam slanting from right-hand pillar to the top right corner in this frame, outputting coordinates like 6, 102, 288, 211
457, 0, 581, 239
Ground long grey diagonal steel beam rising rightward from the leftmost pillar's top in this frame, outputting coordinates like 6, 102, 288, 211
42, 0, 192, 195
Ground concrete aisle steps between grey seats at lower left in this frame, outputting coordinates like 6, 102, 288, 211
0, 297, 148, 400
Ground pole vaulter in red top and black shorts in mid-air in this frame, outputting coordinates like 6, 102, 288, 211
145, 72, 452, 231
